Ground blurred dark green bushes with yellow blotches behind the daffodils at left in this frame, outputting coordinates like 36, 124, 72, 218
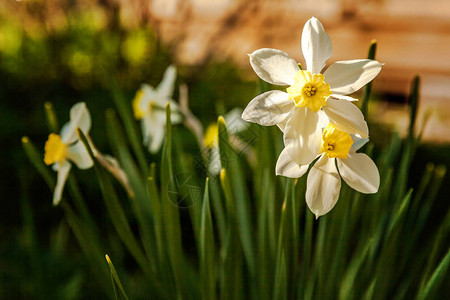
0, 3, 450, 299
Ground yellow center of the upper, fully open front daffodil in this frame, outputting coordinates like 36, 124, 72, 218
286, 70, 332, 112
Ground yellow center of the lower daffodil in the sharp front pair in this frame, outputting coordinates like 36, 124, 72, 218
321, 124, 353, 159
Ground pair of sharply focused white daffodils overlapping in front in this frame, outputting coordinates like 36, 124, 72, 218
242, 17, 383, 218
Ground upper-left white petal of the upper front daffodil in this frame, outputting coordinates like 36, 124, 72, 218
249, 48, 300, 85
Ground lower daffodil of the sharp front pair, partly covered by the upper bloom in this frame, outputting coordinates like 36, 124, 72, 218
276, 123, 380, 218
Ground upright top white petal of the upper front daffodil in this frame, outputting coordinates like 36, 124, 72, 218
302, 17, 332, 74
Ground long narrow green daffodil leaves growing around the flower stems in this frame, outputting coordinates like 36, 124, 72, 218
23, 69, 450, 299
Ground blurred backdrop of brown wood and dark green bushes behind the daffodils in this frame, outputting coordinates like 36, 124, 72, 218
0, 0, 450, 299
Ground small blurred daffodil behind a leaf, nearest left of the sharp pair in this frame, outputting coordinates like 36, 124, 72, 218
203, 107, 248, 176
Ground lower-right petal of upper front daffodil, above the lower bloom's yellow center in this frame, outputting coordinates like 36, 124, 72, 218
322, 98, 369, 138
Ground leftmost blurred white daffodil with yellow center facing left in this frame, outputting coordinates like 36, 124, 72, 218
44, 102, 94, 205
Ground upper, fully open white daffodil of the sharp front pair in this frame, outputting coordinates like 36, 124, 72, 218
242, 17, 383, 165
